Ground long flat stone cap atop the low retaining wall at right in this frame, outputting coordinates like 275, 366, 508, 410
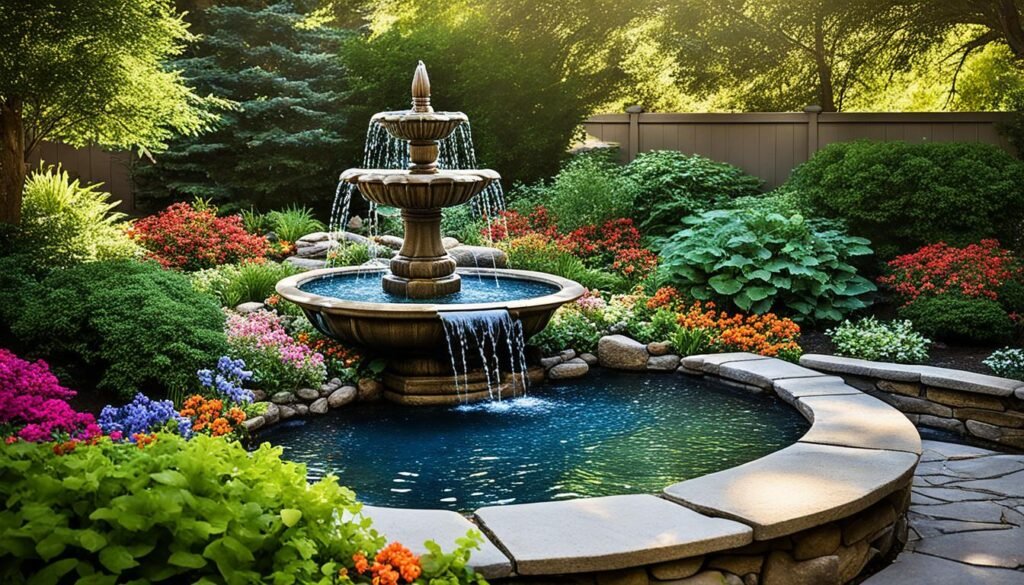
800, 353, 1024, 396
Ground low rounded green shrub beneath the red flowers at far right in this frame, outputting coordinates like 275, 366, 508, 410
899, 295, 1014, 344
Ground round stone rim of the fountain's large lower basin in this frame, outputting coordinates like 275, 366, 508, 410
275, 266, 587, 319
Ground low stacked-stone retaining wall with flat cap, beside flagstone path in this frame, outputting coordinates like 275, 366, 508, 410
800, 354, 1024, 449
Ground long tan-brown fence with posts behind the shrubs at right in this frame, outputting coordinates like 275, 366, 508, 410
584, 108, 1013, 187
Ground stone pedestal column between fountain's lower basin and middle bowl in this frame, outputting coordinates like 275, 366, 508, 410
382, 209, 461, 298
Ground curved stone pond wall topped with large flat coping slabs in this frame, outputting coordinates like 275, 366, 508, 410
356, 352, 922, 585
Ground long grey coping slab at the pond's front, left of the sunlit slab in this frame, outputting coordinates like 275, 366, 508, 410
476, 495, 753, 575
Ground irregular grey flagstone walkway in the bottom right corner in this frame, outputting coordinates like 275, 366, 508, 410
863, 441, 1024, 585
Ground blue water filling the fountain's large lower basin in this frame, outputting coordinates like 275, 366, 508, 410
299, 270, 561, 304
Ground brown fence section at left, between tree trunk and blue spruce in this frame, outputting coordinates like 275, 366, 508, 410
29, 142, 136, 215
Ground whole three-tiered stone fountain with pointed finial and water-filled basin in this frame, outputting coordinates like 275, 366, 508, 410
278, 62, 585, 405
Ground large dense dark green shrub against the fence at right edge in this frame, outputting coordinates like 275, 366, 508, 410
786, 140, 1024, 258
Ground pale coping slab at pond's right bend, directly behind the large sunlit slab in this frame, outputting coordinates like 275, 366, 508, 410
796, 393, 921, 455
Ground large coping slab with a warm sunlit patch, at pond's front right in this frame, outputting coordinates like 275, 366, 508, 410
665, 443, 918, 540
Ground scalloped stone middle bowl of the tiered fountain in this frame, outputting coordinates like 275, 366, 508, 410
341, 169, 501, 209
